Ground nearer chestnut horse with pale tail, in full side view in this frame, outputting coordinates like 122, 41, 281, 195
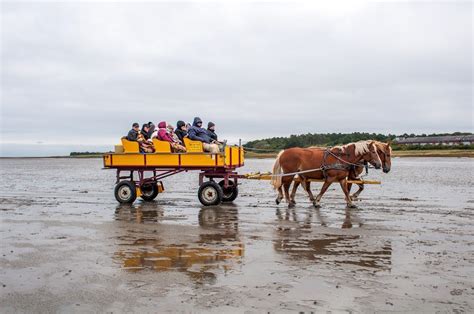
271, 141, 382, 207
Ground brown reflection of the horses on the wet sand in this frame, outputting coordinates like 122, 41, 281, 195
273, 209, 392, 270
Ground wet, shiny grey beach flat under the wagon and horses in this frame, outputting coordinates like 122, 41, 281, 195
0, 158, 474, 313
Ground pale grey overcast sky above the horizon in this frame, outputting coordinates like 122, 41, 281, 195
0, 1, 473, 156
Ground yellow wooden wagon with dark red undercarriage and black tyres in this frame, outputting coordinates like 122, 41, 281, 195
103, 138, 244, 206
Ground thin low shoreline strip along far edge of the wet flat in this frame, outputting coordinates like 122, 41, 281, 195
0, 149, 474, 159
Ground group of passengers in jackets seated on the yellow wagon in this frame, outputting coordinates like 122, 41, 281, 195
126, 117, 225, 154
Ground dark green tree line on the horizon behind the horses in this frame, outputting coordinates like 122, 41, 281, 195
244, 132, 472, 152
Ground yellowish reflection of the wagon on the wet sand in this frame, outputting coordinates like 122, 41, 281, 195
114, 208, 244, 283
